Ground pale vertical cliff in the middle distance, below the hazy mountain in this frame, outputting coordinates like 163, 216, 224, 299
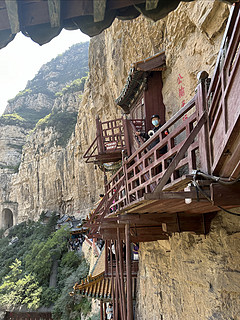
11, 92, 92, 221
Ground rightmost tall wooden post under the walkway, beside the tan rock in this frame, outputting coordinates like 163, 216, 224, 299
125, 224, 133, 320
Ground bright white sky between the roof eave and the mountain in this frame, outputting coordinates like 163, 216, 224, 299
0, 30, 89, 115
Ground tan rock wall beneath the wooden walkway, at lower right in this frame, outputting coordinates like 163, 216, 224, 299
137, 209, 240, 320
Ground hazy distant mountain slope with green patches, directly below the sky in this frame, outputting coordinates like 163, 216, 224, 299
0, 42, 89, 169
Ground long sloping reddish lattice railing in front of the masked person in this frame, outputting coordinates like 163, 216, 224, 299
85, 95, 207, 233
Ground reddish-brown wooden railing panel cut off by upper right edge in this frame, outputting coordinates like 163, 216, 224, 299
207, 3, 240, 178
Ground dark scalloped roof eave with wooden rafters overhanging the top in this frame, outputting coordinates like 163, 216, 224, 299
0, 0, 235, 48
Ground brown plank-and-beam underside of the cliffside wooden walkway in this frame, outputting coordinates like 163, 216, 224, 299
88, 183, 240, 242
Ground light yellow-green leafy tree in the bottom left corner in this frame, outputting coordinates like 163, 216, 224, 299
0, 259, 42, 310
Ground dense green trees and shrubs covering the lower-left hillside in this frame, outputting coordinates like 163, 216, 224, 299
0, 218, 91, 320
